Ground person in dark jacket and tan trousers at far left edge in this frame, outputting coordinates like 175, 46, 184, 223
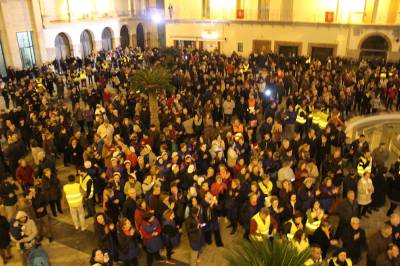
0, 174, 18, 221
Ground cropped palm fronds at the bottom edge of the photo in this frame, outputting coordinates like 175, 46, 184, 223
225, 238, 322, 266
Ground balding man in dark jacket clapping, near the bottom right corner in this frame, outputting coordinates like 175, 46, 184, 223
341, 217, 367, 264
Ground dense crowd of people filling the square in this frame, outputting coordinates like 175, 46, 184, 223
0, 44, 400, 266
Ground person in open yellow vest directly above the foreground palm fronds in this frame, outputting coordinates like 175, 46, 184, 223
250, 207, 278, 241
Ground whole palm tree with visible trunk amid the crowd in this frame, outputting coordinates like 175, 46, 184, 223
129, 66, 172, 128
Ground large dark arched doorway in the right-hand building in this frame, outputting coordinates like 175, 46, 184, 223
360, 35, 389, 60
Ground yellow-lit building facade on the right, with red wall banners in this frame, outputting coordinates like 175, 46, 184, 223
165, 0, 400, 60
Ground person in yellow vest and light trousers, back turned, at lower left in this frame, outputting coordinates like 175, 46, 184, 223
63, 175, 86, 231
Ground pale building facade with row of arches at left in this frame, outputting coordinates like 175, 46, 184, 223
0, 0, 163, 76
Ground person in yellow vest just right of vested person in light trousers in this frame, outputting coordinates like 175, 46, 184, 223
79, 161, 95, 218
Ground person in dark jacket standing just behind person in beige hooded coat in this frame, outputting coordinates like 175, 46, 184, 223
28, 187, 53, 242
